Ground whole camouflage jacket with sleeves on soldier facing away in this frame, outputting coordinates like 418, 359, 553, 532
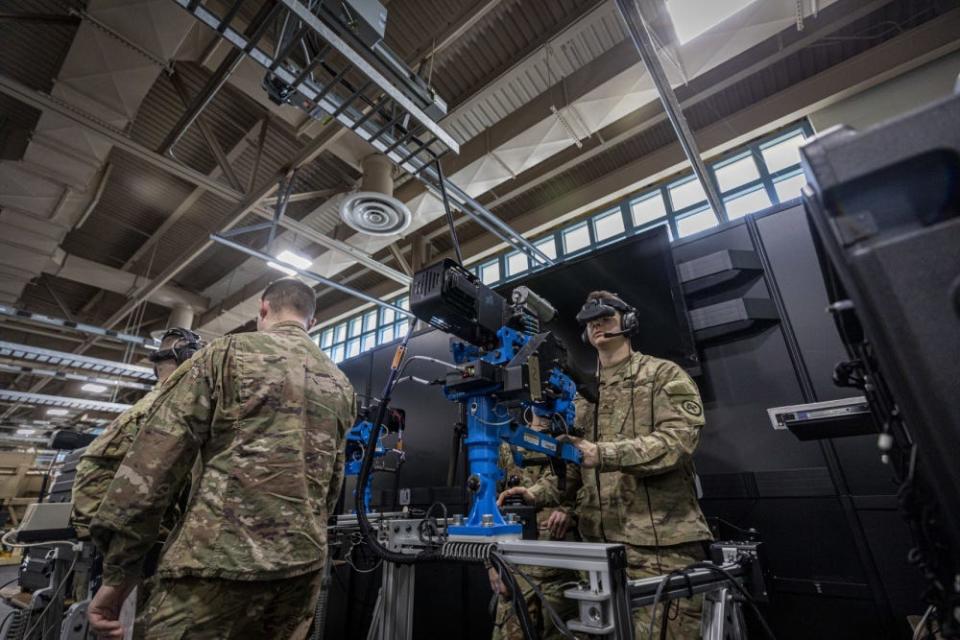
90, 322, 356, 584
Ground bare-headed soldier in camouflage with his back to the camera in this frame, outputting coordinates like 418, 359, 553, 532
88, 278, 356, 639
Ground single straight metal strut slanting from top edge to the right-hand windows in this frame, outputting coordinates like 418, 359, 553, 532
616, 0, 727, 222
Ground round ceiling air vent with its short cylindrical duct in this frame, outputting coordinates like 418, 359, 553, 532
340, 153, 411, 236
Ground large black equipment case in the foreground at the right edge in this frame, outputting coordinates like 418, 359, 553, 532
801, 96, 960, 637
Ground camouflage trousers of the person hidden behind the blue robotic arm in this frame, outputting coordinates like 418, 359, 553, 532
492, 567, 578, 640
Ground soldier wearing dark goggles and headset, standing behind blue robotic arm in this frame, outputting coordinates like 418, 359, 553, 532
501, 291, 711, 639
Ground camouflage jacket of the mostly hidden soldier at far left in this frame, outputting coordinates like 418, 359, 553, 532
70, 385, 160, 538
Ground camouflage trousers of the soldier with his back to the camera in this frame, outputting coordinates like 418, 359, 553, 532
139, 571, 323, 640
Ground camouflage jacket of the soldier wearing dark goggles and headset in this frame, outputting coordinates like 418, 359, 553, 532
531, 353, 711, 546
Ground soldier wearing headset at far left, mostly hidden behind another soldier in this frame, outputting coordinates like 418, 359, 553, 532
70, 327, 202, 638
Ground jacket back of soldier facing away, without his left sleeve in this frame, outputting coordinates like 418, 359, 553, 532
160, 323, 354, 580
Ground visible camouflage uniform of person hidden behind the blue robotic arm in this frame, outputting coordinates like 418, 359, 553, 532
493, 444, 579, 640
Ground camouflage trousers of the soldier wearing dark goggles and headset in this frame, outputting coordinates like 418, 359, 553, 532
624, 542, 706, 640
